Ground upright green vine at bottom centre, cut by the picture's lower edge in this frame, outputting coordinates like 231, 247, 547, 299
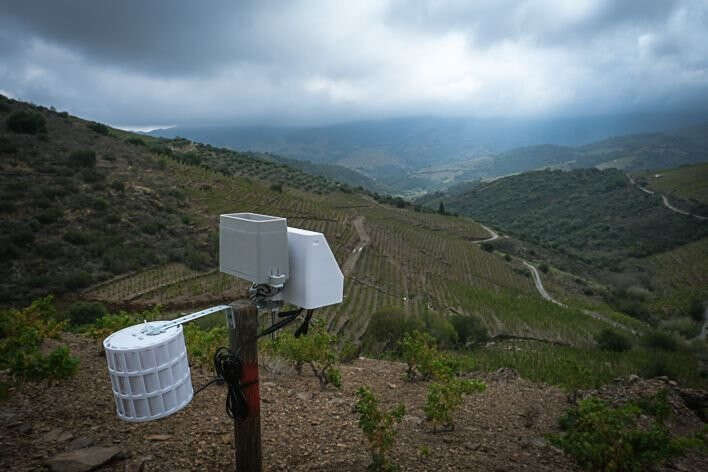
355, 387, 406, 472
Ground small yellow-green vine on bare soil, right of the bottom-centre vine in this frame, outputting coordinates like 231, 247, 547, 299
423, 376, 487, 432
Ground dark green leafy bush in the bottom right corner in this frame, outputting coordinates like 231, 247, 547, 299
551, 397, 682, 471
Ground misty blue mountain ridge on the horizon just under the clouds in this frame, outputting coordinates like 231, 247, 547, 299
150, 113, 706, 171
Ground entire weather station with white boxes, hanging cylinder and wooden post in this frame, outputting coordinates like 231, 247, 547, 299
103, 213, 344, 472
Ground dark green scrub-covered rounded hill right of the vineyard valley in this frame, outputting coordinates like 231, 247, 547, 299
427, 169, 708, 268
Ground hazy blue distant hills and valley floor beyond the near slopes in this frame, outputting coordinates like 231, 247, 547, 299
152, 116, 708, 196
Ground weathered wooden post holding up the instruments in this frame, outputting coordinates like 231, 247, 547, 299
227, 300, 263, 472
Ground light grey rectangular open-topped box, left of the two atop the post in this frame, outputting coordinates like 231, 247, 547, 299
219, 213, 290, 287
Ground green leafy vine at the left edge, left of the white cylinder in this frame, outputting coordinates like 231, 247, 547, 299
0, 297, 79, 381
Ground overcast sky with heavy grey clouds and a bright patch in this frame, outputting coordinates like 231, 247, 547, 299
0, 0, 708, 127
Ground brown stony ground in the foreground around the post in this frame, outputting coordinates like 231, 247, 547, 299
0, 334, 708, 472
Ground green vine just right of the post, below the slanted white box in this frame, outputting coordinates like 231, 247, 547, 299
273, 320, 342, 390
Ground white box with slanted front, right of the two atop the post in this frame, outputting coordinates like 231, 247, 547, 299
282, 228, 344, 309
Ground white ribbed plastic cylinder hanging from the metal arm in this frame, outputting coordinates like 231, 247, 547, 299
103, 321, 194, 422
